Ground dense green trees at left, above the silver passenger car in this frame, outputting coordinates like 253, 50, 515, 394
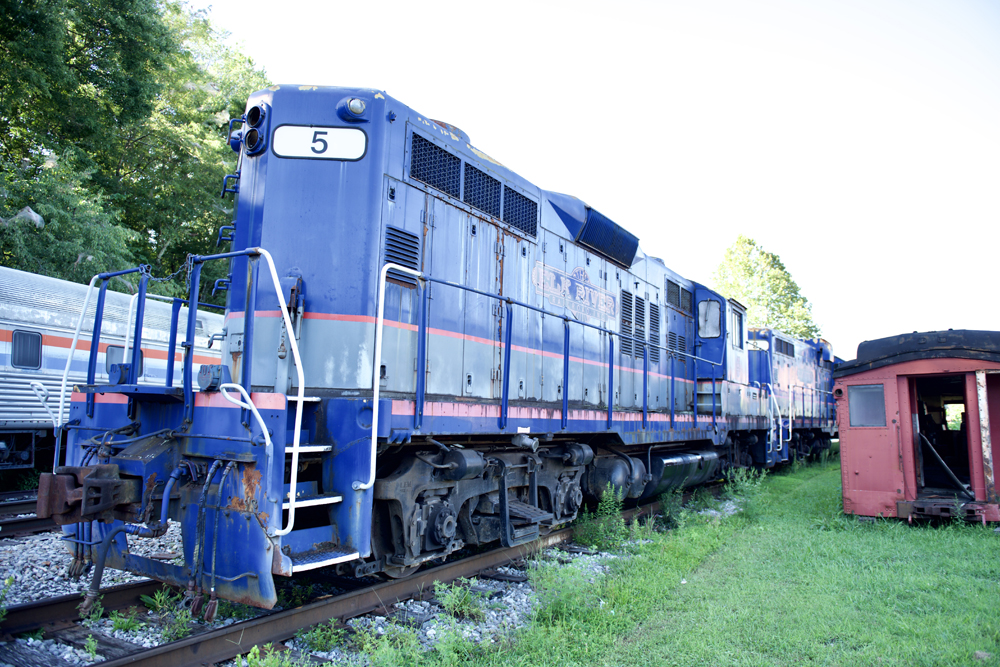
0, 0, 268, 295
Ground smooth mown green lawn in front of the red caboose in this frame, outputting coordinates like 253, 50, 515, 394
601, 464, 1000, 665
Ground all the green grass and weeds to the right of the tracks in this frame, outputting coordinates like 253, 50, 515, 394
251, 461, 1000, 667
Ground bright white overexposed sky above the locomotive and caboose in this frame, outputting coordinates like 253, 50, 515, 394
195, 0, 1000, 359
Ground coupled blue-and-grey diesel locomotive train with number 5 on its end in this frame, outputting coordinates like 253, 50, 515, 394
39, 86, 834, 616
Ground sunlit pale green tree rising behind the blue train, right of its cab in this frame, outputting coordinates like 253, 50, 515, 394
712, 234, 820, 338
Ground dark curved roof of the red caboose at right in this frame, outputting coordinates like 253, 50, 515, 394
833, 329, 1000, 378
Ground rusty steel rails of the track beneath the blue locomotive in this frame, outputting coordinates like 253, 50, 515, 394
0, 503, 658, 667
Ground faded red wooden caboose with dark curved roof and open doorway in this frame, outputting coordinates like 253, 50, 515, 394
833, 330, 1000, 522
